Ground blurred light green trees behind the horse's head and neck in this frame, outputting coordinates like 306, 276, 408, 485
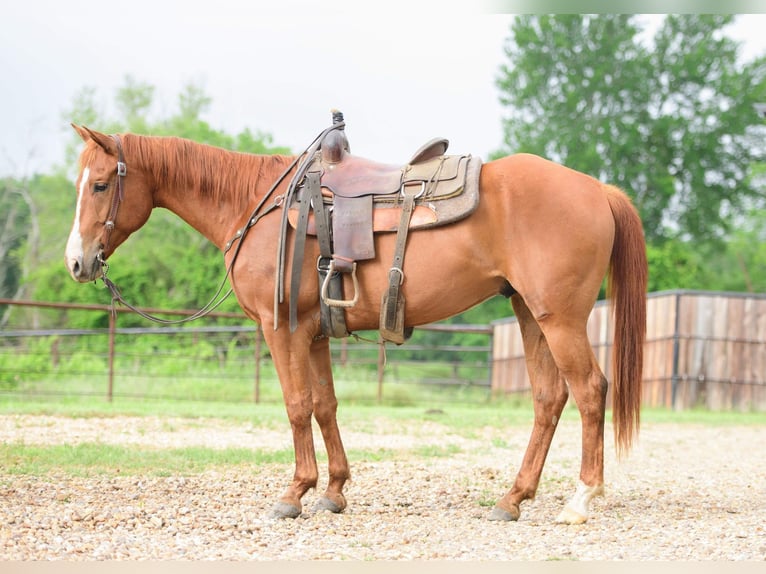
14, 78, 290, 327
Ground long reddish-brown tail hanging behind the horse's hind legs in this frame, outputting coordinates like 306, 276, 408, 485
606, 186, 649, 455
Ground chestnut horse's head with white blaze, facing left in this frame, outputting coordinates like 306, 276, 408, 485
65, 128, 153, 283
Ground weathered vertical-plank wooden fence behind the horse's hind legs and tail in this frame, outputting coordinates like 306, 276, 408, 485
491, 291, 766, 411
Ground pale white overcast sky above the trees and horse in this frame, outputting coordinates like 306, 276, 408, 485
0, 0, 766, 176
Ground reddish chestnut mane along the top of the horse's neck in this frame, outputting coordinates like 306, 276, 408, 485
122, 134, 292, 211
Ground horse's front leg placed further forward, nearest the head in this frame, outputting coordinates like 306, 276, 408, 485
263, 327, 319, 518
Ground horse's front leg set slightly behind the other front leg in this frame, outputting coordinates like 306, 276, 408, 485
310, 338, 351, 513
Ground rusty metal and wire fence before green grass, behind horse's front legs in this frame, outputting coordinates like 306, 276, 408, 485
0, 299, 492, 405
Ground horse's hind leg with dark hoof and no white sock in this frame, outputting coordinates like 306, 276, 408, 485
489, 294, 568, 521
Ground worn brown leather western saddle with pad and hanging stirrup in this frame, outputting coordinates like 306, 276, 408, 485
275, 110, 481, 344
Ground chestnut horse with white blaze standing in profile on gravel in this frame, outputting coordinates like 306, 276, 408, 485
65, 126, 647, 523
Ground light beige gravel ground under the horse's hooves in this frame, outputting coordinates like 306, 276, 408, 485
0, 415, 766, 561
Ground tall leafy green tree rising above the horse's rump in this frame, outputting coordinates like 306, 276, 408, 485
497, 14, 766, 240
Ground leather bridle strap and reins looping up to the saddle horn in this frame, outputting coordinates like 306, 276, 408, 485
98, 124, 345, 325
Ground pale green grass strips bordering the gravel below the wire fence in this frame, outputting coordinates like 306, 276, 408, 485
0, 396, 766, 476
